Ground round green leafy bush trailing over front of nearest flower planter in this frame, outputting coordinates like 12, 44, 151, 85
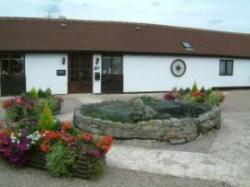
46, 143, 76, 177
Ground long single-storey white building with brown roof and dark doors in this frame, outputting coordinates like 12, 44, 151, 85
0, 17, 250, 95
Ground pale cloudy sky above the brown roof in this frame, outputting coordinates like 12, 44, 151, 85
0, 0, 250, 33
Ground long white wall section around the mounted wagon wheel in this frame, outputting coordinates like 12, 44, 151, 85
123, 55, 250, 92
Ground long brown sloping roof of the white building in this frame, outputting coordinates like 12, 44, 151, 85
0, 17, 250, 58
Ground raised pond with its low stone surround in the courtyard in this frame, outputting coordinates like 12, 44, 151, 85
74, 96, 220, 144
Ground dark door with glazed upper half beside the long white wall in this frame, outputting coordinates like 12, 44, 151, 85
101, 56, 123, 93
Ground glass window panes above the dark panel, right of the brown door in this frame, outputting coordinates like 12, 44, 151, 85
102, 56, 123, 75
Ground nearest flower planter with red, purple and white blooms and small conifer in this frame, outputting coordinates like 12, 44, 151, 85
0, 89, 113, 179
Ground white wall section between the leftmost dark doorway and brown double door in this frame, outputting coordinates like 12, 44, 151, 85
25, 54, 68, 94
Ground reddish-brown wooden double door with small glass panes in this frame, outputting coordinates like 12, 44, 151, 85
69, 53, 92, 93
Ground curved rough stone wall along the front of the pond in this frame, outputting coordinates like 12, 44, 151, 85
74, 107, 220, 144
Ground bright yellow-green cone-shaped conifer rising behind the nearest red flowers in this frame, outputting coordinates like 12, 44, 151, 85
38, 105, 55, 130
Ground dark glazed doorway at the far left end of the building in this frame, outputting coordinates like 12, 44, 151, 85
0, 54, 26, 96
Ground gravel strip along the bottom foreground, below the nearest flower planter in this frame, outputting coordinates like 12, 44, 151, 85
0, 161, 230, 187
